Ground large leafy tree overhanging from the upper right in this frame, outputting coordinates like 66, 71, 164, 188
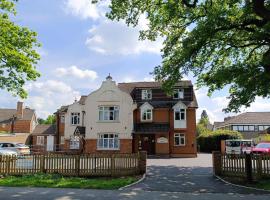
94, 0, 270, 112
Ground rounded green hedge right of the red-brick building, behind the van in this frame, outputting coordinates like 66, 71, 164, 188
197, 130, 243, 153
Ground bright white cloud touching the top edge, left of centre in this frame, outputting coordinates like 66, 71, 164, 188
65, 0, 101, 20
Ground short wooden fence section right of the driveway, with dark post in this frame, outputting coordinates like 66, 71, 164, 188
213, 152, 270, 180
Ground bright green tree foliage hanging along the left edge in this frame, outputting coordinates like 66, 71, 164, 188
0, 0, 40, 98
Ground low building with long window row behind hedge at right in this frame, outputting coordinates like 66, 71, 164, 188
214, 112, 270, 139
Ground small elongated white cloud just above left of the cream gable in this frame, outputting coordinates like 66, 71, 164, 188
55, 65, 98, 80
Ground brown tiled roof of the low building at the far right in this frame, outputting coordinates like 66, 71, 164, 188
216, 112, 270, 127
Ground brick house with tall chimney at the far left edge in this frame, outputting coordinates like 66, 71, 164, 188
0, 102, 37, 143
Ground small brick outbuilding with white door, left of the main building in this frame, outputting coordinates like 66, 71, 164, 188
31, 124, 57, 153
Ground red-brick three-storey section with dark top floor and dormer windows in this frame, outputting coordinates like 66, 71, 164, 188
118, 81, 198, 157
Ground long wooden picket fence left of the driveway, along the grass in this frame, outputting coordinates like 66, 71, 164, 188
0, 152, 146, 176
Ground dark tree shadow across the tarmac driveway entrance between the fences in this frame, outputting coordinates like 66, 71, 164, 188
129, 164, 270, 194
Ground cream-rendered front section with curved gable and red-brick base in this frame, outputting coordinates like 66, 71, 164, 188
62, 76, 136, 153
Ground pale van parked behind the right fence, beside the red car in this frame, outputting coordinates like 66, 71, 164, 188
225, 140, 254, 154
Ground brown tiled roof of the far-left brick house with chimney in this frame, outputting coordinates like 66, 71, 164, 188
0, 108, 35, 123
